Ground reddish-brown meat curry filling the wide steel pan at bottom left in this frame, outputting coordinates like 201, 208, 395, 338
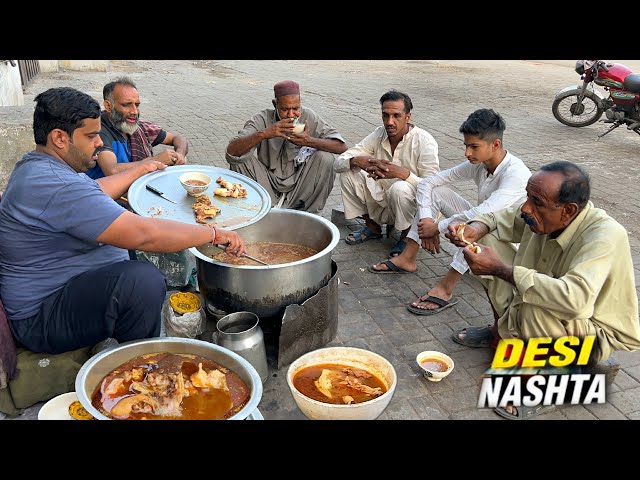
91, 353, 250, 420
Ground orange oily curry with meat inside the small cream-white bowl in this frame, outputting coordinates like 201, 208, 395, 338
292, 363, 388, 405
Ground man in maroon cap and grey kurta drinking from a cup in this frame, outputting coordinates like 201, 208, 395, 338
225, 80, 347, 213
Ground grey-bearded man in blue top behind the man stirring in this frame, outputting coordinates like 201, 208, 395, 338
87, 77, 189, 180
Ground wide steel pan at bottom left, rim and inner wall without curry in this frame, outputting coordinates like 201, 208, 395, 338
76, 337, 262, 420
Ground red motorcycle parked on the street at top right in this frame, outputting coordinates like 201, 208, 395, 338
551, 60, 640, 139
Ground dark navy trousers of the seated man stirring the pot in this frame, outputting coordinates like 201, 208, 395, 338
10, 260, 167, 354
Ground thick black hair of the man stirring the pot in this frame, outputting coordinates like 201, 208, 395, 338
33, 87, 100, 145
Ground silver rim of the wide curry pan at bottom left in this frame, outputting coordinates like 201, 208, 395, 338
75, 337, 263, 420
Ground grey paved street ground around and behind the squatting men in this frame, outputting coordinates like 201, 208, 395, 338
0, 60, 640, 420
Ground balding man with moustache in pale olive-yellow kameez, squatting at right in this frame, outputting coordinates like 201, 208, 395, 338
447, 162, 640, 365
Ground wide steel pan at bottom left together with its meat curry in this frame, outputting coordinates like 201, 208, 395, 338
75, 337, 262, 420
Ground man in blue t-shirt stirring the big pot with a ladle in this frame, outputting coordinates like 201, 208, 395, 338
0, 87, 245, 354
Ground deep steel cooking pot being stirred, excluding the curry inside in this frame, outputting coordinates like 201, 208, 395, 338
190, 208, 340, 317
